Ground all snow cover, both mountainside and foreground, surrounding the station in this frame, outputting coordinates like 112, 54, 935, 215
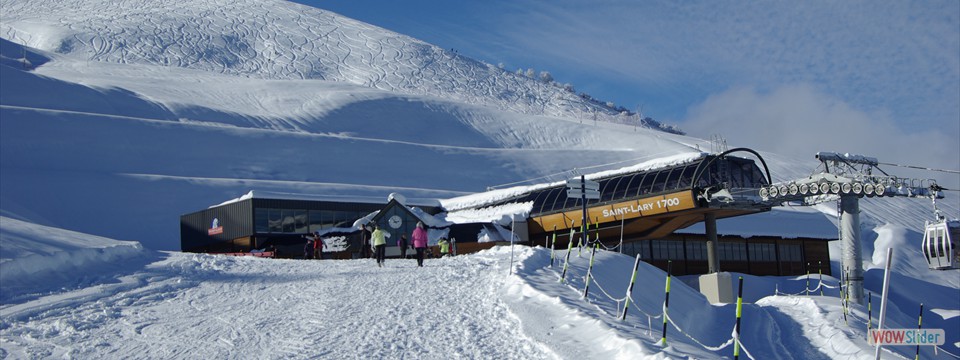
0, 1, 960, 359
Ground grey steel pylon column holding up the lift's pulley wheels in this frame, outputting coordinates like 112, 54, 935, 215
840, 195, 864, 305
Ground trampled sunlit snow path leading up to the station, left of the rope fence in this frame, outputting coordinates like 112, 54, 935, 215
0, 249, 552, 359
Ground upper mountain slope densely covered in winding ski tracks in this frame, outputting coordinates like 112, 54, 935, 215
0, 0, 660, 128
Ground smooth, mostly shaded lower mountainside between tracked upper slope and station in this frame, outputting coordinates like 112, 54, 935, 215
0, 35, 701, 249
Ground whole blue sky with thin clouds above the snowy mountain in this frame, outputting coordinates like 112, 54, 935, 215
299, 0, 960, 182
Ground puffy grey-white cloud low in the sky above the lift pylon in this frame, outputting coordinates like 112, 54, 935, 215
681, 84, 960, 188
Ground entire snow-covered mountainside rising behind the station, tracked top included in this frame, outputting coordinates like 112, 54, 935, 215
0, 1, 960, 268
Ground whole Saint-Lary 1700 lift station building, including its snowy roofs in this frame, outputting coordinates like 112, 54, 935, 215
180, 148, 838, 275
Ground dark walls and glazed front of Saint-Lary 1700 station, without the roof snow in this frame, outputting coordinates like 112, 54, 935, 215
180, 149, 836, 276
